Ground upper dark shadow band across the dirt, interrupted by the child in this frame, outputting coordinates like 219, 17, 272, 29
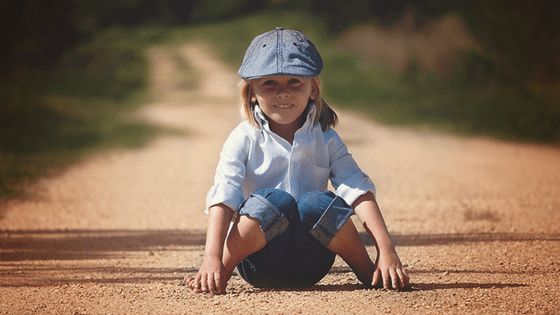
4, 230, 560, 262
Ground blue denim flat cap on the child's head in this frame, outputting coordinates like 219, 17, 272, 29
237, 27, 323, 79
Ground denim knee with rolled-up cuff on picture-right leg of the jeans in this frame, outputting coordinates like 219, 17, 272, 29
297, 191, 354, 246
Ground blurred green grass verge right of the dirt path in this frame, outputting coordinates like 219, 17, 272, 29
323, 55, 560, 145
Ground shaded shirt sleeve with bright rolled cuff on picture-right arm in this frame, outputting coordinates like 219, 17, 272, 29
327, 130, 376, 209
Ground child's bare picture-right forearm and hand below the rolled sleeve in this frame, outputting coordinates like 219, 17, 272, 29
352, 192, 409, 289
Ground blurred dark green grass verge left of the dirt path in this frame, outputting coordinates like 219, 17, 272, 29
0, 27, 187, 198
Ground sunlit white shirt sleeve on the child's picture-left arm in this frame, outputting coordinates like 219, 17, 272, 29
206, 126, 250, 213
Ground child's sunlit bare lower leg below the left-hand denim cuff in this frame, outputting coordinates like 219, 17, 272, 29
222, 215, 266, 279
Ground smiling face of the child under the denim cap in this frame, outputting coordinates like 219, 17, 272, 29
251, 75, 317, 125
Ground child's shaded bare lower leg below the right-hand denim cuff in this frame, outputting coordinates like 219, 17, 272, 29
327, 219, 375, 286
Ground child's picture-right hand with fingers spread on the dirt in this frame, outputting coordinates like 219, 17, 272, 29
371, 250, 410, 290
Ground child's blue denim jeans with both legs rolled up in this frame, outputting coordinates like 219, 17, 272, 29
237, 189, 353, 287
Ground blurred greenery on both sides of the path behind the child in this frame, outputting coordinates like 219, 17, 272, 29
0, 0, 560, 198
